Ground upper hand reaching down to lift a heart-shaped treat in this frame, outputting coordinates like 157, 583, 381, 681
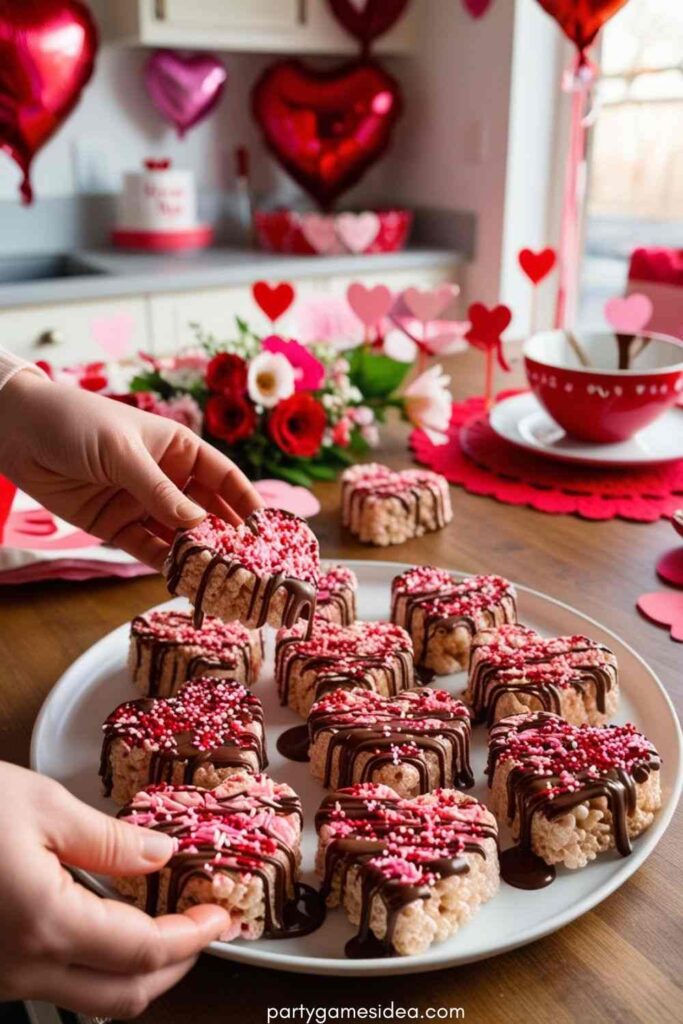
0, 372, 263, 568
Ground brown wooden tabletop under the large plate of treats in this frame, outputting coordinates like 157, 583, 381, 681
0, 353, 683, 1024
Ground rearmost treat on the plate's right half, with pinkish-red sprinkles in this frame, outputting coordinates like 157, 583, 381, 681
391, 565, 517, 678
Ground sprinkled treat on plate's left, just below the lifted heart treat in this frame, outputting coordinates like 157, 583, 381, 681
128, 611, 263, 697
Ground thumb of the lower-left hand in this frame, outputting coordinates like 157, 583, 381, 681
45, 787, 175, 874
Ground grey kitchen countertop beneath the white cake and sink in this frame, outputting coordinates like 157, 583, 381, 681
0, 248, 463, 309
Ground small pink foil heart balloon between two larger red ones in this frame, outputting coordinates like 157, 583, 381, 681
143, 50, 227, 138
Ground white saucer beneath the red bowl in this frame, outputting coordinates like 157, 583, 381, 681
488, 391, 683, 466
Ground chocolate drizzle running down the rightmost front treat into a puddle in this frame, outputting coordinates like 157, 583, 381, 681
486, 712, 660, 889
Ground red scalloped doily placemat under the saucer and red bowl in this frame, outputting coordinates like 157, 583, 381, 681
411, 391, 683, 522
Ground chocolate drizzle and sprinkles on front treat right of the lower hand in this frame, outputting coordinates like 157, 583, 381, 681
315, 785, 498, 958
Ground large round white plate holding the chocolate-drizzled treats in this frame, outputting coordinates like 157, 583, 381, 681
31, 561, 683, 975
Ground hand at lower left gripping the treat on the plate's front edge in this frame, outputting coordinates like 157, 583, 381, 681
0, 763, 228, 1018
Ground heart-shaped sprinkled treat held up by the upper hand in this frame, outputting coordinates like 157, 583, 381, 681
164, 509, 319, 629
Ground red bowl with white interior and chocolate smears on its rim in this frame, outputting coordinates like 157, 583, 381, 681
523, 331, 683, 444
